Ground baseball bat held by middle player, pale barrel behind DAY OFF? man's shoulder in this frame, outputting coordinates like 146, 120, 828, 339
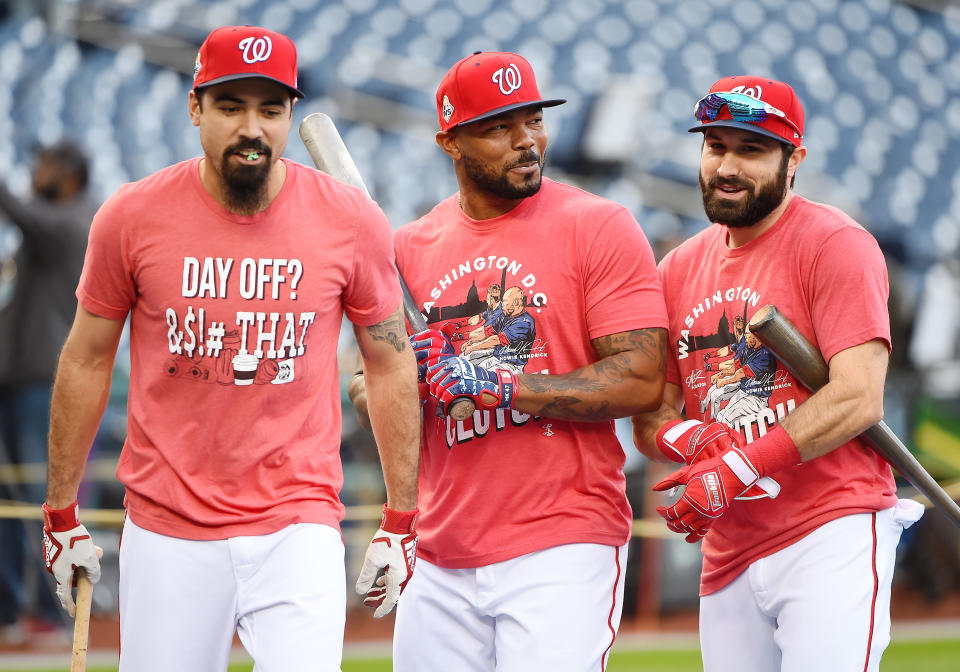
300, 112, 476, 420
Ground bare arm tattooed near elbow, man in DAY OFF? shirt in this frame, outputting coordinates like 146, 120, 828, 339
353, 308, 420, 511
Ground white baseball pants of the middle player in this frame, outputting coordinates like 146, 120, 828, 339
393, 544, 627, 672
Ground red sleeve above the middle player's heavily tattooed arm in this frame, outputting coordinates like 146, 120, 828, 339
584, 208, 667, 339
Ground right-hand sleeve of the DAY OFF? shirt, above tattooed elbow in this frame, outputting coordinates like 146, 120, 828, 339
343, 193, 401, 327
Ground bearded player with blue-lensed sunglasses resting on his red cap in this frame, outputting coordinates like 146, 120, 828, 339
634, 76, 922, 672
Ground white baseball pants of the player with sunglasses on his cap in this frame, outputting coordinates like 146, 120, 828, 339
700, 499, 923, 672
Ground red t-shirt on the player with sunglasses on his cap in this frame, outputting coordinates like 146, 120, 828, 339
660, 196, 896, 595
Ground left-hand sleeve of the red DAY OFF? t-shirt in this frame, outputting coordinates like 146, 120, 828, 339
77, 190, 137, 320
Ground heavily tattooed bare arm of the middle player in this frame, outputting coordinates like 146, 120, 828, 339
513, 329, 667, 421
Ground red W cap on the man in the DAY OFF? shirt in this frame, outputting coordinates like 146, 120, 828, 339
193, 26, 303, 98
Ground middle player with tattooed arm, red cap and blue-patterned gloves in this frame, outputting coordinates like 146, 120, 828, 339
352, 53, 666, 672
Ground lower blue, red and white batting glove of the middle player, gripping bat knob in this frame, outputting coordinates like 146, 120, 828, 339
427, 357, 517, 410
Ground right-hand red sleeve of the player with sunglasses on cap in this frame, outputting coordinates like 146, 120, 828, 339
809, 226, 890, 362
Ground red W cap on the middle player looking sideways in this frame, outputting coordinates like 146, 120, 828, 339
437, 51, 567, 131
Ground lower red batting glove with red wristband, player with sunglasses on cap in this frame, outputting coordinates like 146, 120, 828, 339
653, 423, 801, 543
